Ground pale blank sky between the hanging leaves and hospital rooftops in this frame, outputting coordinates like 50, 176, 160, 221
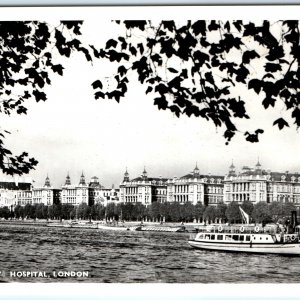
2, 7, 300, 187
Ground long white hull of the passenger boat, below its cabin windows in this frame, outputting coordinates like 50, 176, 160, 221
189, 240, 300, 255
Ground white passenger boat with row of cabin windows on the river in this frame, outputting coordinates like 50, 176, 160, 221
188, 224, 300, 255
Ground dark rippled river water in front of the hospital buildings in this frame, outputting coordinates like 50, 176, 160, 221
0, 225, 300, 283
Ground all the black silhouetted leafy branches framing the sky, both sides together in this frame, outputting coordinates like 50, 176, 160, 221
0, 20, 300, 175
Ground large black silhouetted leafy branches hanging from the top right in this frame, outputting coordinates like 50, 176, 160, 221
92, 20, 300, 144
